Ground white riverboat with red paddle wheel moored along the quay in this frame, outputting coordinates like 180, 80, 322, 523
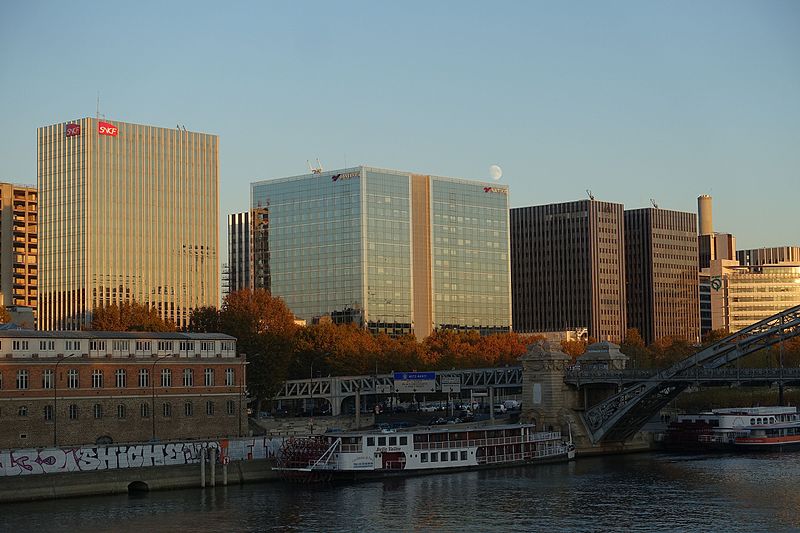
276, 424, 575, 481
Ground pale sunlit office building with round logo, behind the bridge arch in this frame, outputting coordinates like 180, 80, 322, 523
702, 260, 800, 333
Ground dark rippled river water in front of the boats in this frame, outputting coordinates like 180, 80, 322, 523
0, 453, 800, 533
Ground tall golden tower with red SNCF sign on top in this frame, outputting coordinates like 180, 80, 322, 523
37, 118, 220, 329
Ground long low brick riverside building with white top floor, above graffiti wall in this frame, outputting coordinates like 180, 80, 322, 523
0, 330, 247, 448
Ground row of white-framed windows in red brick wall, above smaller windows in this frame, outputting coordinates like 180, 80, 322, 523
0, 368, 236, 390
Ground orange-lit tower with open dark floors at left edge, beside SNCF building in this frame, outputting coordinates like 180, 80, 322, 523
0, 183, 39, 309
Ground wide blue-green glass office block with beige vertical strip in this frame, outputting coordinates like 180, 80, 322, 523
250, 166, 511, 338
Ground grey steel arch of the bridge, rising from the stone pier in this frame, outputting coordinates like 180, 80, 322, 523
582, 305, 800, 443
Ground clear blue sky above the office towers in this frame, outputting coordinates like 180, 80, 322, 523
0, 0, 800, 259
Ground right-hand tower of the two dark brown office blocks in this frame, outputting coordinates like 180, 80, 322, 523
625, 207, 700, 344
